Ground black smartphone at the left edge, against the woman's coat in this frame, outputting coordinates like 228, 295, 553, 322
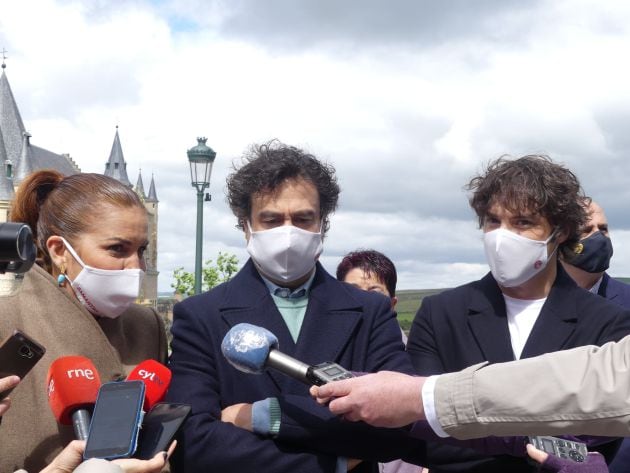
0, 330, 46, 399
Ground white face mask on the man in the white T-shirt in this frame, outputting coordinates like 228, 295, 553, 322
483, 228, 558, 287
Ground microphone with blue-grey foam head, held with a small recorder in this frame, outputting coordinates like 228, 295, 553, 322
221, 323, 354, 386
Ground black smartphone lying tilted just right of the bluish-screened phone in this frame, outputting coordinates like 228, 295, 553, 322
134, 402, 191, 460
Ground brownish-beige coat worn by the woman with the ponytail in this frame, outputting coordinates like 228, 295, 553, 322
0, 266, 167, 473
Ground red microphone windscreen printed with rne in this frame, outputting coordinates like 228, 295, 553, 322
46, 356, 101, 425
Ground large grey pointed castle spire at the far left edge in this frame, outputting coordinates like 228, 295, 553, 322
0, 68, 26, 170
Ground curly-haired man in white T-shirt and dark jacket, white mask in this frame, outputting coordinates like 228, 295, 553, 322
407, 156, 630, 473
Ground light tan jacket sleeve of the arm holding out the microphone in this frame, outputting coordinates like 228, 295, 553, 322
435, 336, 630, 439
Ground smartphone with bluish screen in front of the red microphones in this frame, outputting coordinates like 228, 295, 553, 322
83, 381, 144, 460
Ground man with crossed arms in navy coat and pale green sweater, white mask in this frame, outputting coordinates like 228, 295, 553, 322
167, 141, 418, 473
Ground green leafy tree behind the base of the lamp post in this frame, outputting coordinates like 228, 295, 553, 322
171, 251, 238, 297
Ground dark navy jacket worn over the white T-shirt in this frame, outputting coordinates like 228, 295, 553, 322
407, 265, 630, 473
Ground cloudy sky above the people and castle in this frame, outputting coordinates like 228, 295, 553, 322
0, 0, 630, 291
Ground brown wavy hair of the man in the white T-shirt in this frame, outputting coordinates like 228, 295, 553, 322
466, 155, 588, 251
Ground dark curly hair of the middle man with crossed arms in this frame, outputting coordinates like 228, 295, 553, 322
227, 140, 340, 233
